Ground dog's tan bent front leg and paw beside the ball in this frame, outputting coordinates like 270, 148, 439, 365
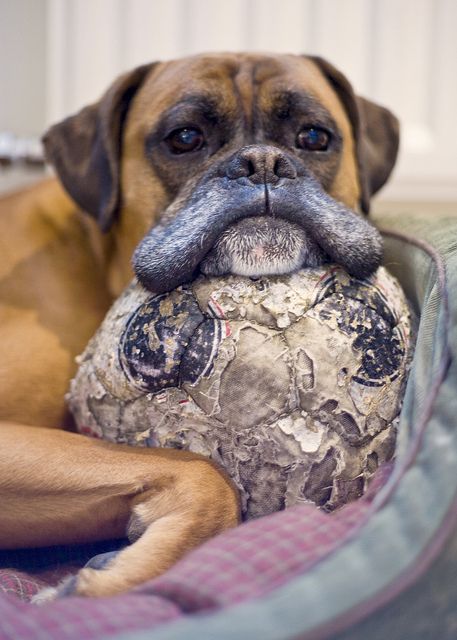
0, 424, 239, 596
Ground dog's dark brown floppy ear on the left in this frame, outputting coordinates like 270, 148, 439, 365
43, 64, 154, 231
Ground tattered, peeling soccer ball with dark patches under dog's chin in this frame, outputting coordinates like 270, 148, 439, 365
69, 265, 410, 518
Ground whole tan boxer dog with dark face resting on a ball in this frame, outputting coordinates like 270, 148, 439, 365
0, 54, 398, 596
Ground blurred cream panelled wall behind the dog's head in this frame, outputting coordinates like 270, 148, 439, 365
0, 0, 457, 211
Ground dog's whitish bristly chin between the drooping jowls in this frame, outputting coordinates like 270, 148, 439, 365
200, 215, 328, 277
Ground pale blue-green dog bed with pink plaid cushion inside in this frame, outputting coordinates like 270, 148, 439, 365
0, 212, 457, 640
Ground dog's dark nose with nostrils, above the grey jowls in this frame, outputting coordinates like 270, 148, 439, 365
226, 145, 297, 184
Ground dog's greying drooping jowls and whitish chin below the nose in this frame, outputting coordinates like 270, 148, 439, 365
133, 170, 383, 294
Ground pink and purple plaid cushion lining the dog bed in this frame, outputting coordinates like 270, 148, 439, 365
0, 467, 390, 640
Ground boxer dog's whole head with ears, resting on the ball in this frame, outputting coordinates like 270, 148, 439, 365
44, 54, 398, 292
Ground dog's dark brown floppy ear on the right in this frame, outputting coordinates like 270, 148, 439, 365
310, 56, 400, 213
